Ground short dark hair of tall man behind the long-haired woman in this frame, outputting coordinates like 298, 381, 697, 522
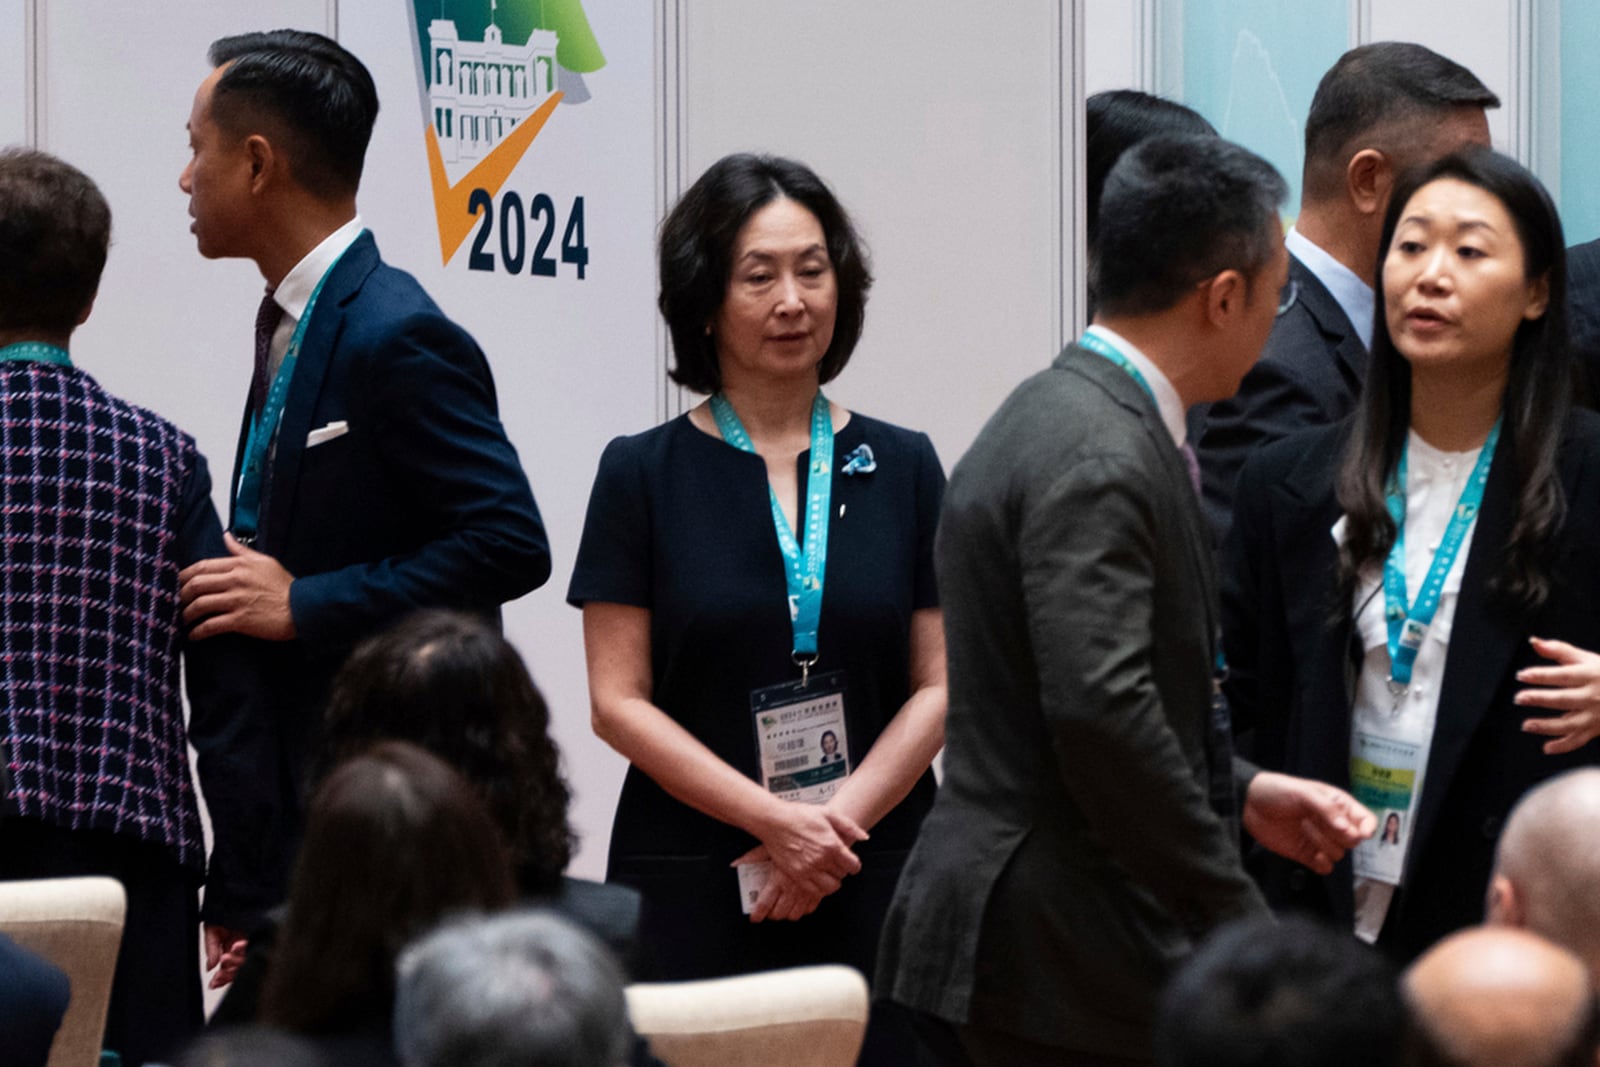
1302, 40, 1499, 200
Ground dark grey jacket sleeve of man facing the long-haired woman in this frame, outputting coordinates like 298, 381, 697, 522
1019, 456, 1262, 929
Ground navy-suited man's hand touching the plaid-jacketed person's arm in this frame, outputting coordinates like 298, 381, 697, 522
178, 534, 294, 641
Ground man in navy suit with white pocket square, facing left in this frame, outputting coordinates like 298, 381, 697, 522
179, 30, 550, 966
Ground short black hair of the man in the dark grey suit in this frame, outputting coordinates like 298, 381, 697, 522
1090, 134, 1288, 315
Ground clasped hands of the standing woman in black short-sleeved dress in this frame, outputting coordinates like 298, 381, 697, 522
733, 801, 867, 923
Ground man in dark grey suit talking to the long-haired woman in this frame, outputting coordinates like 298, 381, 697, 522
878, 138, 1373, 1064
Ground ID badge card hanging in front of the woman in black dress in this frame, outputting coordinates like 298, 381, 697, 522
750, 670, 850, 805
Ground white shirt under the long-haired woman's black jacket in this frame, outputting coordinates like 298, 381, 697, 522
1333, 432, 1482, 942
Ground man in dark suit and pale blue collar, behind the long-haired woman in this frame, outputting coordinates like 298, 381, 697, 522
1200, 42, 1499, 542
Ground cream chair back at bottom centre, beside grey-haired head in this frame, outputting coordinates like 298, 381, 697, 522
627, 966, 867, 1067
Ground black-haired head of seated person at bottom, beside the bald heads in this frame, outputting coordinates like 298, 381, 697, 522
1155, 917, 1405, 1067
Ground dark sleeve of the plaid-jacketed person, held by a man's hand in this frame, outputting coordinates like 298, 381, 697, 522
176, 454, 291, 929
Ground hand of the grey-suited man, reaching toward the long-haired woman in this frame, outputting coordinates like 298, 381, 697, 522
1245, 771, 1378, 875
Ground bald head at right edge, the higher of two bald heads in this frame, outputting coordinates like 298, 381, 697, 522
1488, 768, 1600, 985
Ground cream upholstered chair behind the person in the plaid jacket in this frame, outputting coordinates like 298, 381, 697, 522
0, 878, 128, 1067
